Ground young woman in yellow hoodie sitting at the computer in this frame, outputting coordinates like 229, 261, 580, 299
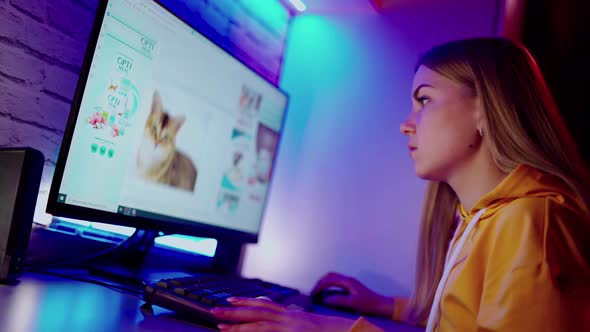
210, 38, 590, 332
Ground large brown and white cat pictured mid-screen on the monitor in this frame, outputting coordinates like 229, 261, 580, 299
137, 90, 197, 191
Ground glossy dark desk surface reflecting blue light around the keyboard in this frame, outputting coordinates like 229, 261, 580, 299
0, 273, 423, 332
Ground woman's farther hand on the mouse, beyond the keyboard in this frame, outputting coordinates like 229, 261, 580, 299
311, 272, 393, 318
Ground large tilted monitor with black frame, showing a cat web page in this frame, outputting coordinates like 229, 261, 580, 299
47, 0, 288, 242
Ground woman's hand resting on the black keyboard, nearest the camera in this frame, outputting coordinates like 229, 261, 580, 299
211, 298, 354, 332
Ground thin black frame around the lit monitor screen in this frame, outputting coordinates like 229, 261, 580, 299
46, 0, 290, 243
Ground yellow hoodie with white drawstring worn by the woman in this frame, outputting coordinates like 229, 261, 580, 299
351, 165, 590, 332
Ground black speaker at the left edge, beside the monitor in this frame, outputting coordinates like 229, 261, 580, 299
0, 148, 45, 282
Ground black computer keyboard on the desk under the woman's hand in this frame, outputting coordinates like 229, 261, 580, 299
143, 274, 311, 326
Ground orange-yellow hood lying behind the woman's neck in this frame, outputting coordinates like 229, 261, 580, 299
459, 165, 580, 224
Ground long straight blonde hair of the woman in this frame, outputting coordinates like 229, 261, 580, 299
406, 38, 590, 323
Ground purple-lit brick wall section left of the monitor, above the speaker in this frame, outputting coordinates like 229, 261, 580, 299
0, 0, 94, 172
